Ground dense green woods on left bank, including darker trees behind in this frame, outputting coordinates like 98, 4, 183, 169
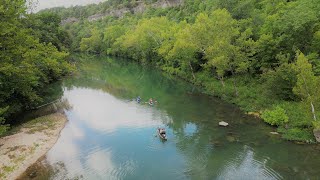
0, 0, 74, 135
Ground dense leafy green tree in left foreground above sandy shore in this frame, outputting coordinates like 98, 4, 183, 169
0, 0, 71, 134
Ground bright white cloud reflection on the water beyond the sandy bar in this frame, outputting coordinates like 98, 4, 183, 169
65, 88, 163, 133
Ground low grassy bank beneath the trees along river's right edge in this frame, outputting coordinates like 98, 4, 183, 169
193, 71, 320, 143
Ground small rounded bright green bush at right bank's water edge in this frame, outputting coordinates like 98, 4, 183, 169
261, 106, 289, 126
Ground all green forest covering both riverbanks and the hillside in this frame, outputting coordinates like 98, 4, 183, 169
0, 0, 320, 143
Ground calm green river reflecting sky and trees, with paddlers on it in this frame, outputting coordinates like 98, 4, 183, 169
18, 55, 320, 180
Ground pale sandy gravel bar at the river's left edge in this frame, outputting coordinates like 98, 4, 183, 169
0, 113, 67, 180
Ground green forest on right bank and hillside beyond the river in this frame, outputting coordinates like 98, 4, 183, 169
43, 0, 320, 142
